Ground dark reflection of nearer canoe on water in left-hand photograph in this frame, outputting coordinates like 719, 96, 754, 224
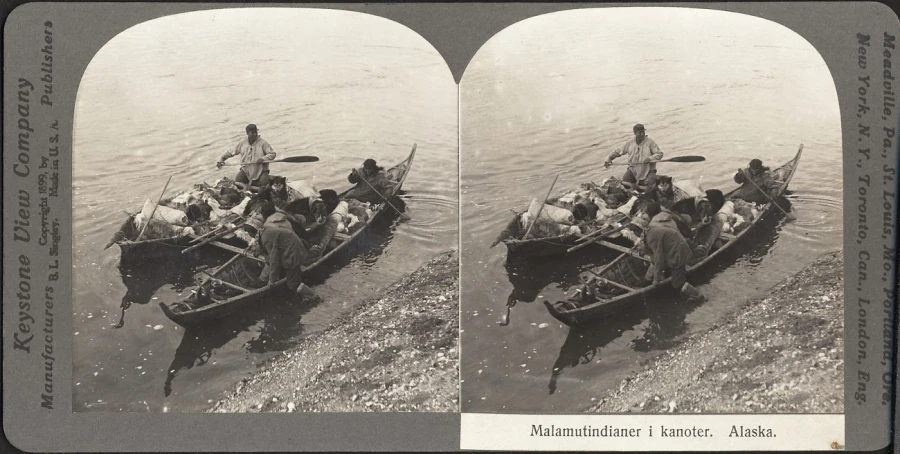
158, 206, 403, 397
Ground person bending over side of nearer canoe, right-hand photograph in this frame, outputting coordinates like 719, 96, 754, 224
644, 202, 702, 300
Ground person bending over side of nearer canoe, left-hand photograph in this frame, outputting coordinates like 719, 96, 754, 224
258, 201, 318, 300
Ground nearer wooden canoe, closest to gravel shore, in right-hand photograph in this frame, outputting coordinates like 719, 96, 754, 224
544, 144, 803, 326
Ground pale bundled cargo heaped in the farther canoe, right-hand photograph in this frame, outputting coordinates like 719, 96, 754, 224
491, 177, 693, 257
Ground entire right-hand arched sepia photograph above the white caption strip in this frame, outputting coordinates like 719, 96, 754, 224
459, 7, 844, 414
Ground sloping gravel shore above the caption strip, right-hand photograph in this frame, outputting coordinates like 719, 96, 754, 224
588, 251, 844, 413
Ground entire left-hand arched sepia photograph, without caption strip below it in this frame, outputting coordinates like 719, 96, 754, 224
72, 8, 459, 413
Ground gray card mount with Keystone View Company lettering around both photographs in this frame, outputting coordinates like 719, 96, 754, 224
3, 2, 900, 451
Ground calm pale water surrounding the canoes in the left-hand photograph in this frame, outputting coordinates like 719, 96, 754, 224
73, 8, 458, 412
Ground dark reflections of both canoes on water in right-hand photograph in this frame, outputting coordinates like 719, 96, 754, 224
536, 203, 789, 394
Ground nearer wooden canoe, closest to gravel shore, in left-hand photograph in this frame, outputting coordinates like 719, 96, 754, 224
159, 145, 416, 326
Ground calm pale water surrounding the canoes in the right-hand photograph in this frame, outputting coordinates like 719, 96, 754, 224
460, 8, 843, 412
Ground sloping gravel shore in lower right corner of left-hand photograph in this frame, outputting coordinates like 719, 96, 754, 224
208, 250, 459, 413
